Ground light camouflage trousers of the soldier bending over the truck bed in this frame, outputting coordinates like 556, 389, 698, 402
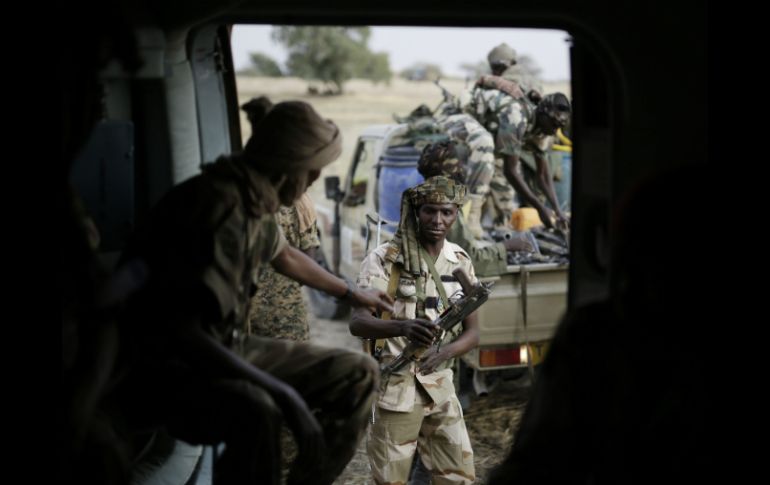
439, 114, 495, 195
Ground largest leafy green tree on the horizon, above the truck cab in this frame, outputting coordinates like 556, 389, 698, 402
272, 26, 390, 94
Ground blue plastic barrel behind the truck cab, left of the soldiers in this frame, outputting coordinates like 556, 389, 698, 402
377, 146, 425, 224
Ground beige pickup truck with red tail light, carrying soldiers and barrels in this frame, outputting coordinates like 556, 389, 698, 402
311, 124, 568, 393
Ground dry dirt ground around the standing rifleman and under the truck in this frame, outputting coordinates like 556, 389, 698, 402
310, 317, 530, 485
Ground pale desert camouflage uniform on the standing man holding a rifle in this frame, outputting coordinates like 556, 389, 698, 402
357, 241, 477, 484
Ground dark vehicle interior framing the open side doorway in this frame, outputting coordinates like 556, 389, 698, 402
59, 0, 708, 483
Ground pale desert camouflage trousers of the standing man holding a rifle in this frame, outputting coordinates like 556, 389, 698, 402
366, 385, 476, 485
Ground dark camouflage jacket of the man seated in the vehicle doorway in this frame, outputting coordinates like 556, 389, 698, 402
124, 164, 288, 346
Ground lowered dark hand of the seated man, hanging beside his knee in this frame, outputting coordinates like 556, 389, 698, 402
273, 384, 325, 470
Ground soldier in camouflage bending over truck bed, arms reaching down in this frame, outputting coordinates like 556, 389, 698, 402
465, 81, 570, 231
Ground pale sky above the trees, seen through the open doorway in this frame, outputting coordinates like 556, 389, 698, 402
232, 25, 570, 81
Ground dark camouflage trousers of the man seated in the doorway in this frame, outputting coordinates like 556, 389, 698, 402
240, 337, 379, 483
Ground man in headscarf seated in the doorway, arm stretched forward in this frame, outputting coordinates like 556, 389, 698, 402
117, 101, 391, 483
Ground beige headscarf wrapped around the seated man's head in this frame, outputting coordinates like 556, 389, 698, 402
244, 101, 342, 174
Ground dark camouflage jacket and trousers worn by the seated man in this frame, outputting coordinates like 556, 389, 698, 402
119, 158, 378, 483
